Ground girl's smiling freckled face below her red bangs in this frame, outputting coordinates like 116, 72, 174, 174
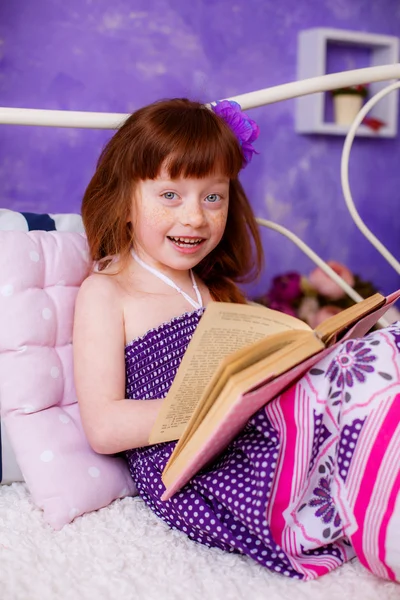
131, 169, 229, 270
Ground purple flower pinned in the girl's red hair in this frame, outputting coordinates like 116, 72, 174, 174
211, 100, 260, 164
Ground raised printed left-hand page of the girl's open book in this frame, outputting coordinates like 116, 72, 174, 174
149, 302, 310, 444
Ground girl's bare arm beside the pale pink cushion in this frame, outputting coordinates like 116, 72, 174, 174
73, 274, 163, 454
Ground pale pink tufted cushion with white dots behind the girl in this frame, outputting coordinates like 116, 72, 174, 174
0, 231, 136, 529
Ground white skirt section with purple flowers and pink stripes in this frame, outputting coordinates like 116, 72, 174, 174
264, 323, 400, 581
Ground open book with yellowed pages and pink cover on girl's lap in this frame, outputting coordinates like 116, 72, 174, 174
149, 290, 400, 500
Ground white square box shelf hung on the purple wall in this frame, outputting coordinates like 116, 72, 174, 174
295, 28, 399, 138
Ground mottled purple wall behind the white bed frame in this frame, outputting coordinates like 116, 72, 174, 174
0, 0, 400, 292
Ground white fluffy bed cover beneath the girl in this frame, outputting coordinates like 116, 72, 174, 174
0, 484, 400, 600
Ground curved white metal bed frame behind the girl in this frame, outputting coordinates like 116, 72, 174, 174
0, 63, 400, 326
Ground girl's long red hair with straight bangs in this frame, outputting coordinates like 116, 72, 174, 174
82, 99, 263, 302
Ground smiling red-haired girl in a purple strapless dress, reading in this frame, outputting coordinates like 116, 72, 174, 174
74, 99, 400, 579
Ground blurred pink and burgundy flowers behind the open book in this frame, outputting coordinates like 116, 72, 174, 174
255, 260, 400, 329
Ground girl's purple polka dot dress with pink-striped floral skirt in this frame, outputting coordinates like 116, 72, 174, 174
125, 309, 400, 580
